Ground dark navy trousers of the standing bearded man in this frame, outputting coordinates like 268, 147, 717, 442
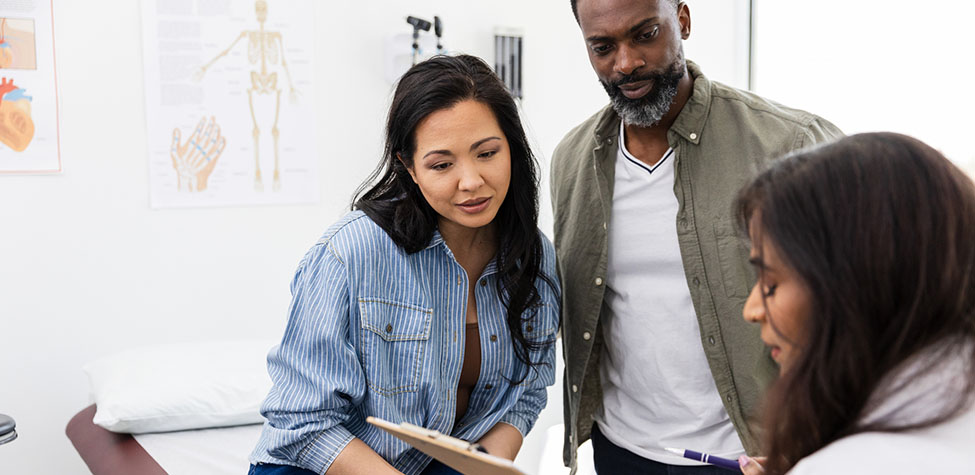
590, 423, 733, 475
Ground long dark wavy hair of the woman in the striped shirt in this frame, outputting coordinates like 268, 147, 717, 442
353, 55, 556, 383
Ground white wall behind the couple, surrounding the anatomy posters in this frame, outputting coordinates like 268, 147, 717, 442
0, 0, 744, 474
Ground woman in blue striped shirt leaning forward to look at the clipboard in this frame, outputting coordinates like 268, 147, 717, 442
251, 56, 560, 474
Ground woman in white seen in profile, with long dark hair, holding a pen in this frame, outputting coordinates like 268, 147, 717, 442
736, 133, 975, 474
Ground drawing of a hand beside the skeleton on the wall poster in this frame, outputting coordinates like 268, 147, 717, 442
169, 117, 227, 191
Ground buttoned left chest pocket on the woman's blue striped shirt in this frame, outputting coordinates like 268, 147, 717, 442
359, 298, 433, 395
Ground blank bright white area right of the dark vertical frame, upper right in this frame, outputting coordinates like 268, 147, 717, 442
754, 0, 975, 173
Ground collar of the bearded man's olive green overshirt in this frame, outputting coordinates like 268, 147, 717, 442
594, 61, 711, 146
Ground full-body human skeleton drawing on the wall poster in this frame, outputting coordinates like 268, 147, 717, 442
196, 0, 297, 191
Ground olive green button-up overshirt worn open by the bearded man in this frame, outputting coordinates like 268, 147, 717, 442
551, 62, 842, 471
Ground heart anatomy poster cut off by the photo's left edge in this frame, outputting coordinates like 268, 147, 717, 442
0, 0, 61, 173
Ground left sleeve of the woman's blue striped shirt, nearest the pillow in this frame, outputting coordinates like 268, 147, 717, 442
259, 242, 366, 473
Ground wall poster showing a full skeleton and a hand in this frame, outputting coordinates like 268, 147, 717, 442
142, 0, 319, 208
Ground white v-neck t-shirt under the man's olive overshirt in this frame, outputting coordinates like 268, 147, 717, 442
596, 124, 745, 465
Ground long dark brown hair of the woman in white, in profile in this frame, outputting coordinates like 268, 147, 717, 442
735, 133, 975, 474
